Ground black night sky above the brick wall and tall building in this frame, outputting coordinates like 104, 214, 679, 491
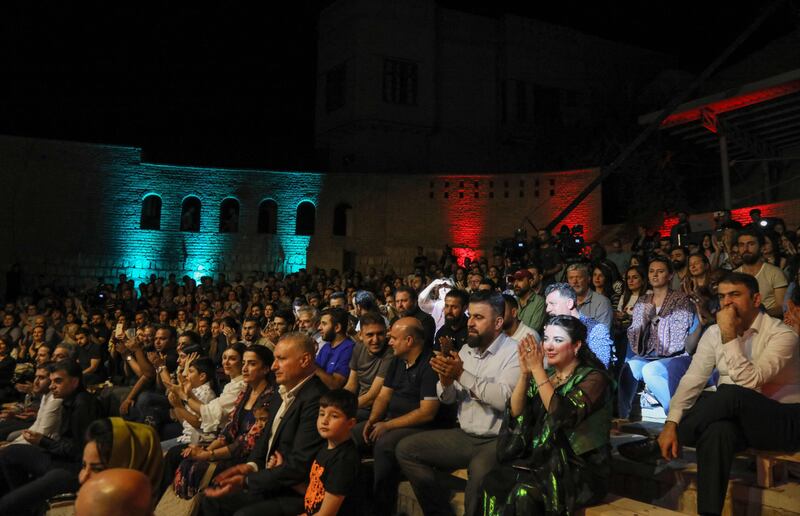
0, 0, 798, 170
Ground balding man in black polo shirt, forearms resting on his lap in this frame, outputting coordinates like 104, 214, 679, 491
353, 317, 441, 514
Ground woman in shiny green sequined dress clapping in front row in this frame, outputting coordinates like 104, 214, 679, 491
483, 315, 613, 516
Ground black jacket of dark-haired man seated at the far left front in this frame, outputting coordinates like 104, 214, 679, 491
40, 389, 100, 462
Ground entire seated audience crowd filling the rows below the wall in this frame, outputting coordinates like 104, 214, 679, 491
0, 210, 800, 515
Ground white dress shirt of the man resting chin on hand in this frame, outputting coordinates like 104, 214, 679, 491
667, 313, 800, 423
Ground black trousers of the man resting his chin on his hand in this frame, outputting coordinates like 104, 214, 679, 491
678, 384, 800, 514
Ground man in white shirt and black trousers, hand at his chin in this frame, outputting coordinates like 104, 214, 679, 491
658, 273, 800, 514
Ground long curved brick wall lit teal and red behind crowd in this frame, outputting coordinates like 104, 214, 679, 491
0, 136, 601, 283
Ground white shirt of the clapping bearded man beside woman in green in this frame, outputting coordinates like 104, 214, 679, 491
436, 333, 519, 436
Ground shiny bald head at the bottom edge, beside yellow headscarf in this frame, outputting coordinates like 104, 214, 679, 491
75, 468, 153, 516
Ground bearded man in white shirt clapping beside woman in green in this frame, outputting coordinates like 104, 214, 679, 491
396, 292, 519, 515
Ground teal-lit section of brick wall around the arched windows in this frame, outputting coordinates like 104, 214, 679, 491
103, 154, 324, 281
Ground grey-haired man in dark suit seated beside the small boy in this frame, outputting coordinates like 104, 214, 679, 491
202, 333, 327, 516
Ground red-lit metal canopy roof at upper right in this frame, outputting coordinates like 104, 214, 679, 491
639, 69, 800, 160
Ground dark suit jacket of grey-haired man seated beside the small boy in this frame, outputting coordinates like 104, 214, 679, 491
247, 376, 328, 494
